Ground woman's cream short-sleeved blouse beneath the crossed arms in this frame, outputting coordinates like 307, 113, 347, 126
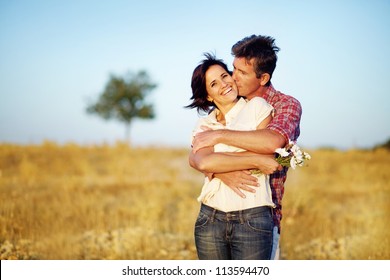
193, 97, 275, 212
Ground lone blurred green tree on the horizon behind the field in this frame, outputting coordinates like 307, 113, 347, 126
87, 71, 157, 141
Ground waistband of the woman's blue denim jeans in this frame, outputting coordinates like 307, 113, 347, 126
200, 203, 272, 222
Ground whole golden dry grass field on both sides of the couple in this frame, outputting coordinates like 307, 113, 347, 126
0, 142, 390, 260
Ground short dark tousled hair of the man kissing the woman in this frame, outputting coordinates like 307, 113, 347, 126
232, 35, 280, 86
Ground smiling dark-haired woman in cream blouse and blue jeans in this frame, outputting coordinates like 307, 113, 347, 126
187, 54, 274, 259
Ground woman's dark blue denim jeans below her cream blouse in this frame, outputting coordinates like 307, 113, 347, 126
195, 204, 274, 260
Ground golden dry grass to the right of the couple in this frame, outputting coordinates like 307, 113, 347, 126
282, 150, 390, 260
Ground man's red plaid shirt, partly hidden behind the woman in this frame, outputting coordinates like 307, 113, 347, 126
262, 85, 302, 232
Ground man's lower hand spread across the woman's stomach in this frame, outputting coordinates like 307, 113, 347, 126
214, 170, 259, 198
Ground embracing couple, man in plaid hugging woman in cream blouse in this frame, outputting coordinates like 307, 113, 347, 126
187, 35, 302, 260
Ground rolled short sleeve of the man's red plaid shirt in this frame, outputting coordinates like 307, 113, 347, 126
267, 95, 302, 144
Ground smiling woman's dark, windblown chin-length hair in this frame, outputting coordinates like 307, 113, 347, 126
185, 53, 231, 114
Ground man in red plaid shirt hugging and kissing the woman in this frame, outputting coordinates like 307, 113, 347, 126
189, 35, 302, 259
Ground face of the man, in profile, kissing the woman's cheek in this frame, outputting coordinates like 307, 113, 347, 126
233, 57, 261, 99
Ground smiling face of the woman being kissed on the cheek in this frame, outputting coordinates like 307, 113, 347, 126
206, 65, 238, 110
